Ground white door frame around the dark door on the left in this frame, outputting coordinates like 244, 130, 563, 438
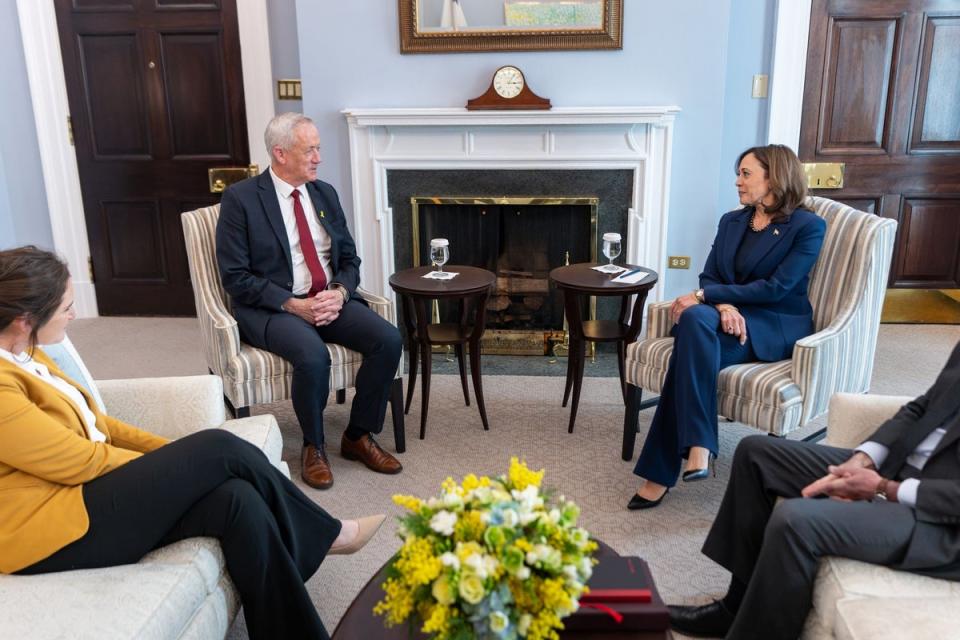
17, 0, 274, 318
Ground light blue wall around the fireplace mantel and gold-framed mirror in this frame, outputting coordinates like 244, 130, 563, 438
297, 0, 773, 296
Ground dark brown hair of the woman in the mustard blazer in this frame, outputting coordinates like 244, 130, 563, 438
0, 246, 70, 350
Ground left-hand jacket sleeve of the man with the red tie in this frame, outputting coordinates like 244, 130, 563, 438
217, 188, 293, 311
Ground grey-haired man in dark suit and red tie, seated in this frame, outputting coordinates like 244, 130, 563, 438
217, 113, 402, 489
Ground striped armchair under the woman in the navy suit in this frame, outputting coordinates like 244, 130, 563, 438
622, 196, 897, 460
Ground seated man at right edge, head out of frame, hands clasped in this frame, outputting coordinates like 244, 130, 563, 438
670, 344, 960, 638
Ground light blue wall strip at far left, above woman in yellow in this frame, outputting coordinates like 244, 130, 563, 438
0, 0, 53, 249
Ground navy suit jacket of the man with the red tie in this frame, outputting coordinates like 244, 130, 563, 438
217, 169, 360, 344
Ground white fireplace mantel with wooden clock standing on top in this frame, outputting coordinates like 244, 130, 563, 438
342, 106, 680, 308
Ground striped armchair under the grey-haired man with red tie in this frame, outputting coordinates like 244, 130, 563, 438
180, 204, 406, 453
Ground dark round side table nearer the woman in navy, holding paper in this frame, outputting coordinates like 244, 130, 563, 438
550, 262, 658, 433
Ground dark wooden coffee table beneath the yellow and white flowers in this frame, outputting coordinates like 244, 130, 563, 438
331, 541, 673, 640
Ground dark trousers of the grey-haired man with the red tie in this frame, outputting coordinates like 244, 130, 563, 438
254, 300, 403, 445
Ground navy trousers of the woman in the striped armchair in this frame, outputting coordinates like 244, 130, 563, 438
633, 304, 757, 487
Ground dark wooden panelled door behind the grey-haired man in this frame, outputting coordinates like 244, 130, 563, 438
56, 0, 249, 315
